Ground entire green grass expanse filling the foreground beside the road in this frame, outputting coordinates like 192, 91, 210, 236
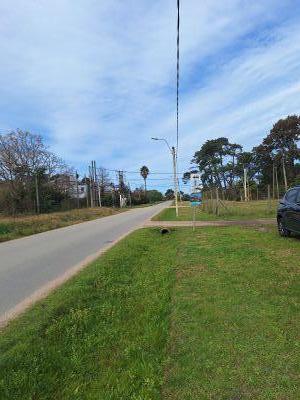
0, 227, 300, 400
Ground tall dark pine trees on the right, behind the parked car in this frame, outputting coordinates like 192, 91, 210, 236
182, 115, 300, 198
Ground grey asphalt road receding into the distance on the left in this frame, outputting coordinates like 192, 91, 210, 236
0, 202, 170, 319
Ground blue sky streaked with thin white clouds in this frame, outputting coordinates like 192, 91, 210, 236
0, 0, 300, 191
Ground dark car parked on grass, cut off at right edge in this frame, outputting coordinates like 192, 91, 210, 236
277, 186, 300, 236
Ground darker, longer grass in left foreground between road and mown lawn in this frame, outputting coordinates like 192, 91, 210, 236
0, 230, 175, 400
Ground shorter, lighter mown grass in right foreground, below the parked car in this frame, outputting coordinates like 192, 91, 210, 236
164, 228, 300, 400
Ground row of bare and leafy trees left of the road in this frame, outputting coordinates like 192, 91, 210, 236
0, 129, 163, 214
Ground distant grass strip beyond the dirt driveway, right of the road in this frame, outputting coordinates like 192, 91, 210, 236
152, 200, 278, 221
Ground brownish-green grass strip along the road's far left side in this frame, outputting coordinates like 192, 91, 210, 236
0, 207, 126, 242
